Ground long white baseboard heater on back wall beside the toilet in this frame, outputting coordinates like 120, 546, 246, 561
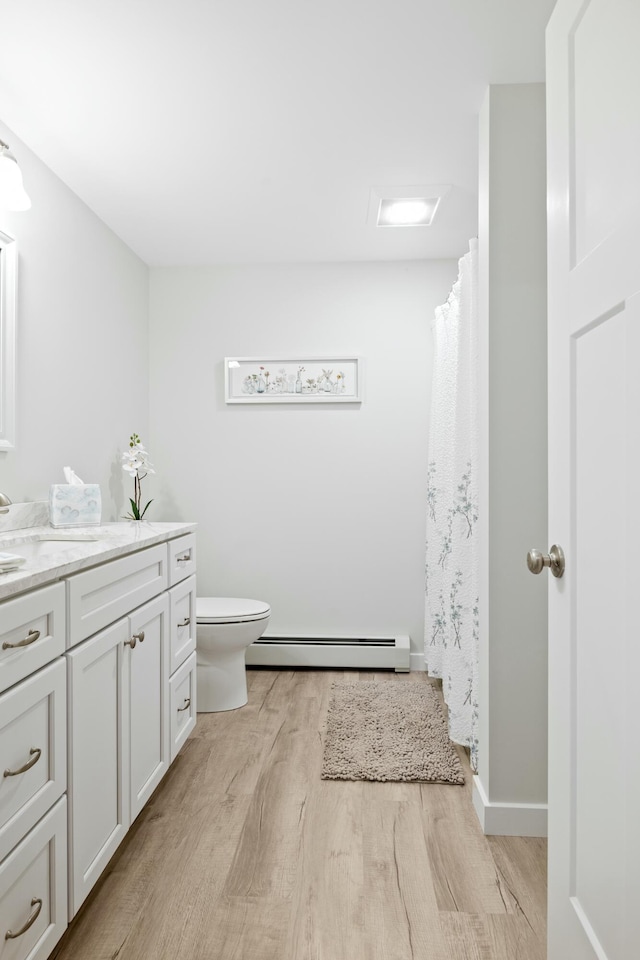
246, 634, 410, 673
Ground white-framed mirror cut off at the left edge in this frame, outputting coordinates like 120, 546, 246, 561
0, 230, 18, 452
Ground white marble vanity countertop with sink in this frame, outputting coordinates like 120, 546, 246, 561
0, 520, 196, 600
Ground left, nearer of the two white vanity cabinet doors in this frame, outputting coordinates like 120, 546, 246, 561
67, 618, 130, 919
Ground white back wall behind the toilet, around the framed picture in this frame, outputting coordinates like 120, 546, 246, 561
150, 261, 457, 651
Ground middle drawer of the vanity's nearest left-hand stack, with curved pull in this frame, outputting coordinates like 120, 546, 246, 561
0, 658, 67, 864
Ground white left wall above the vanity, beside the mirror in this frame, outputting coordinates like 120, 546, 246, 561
0, 123, 149, 520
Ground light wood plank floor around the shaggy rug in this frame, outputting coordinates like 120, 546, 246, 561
56, 670, 546, 960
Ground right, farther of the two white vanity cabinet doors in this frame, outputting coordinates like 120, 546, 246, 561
127, 594, 169, 821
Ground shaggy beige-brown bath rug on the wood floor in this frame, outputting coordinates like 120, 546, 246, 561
322, 680, 464, 783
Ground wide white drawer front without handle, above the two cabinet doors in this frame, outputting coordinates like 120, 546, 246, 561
67, 544, 167, 646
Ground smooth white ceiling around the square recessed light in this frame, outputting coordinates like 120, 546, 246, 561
0, 0, 554, 265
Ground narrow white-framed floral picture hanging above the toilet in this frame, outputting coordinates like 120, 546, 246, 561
224, 355, 362, 404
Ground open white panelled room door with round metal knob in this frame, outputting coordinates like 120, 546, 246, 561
547, 0, 640, 960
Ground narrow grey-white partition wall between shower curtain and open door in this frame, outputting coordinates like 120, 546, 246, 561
476, 84, 549, 832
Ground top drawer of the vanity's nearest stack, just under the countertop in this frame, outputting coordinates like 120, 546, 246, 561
0, 583, 65, 691
